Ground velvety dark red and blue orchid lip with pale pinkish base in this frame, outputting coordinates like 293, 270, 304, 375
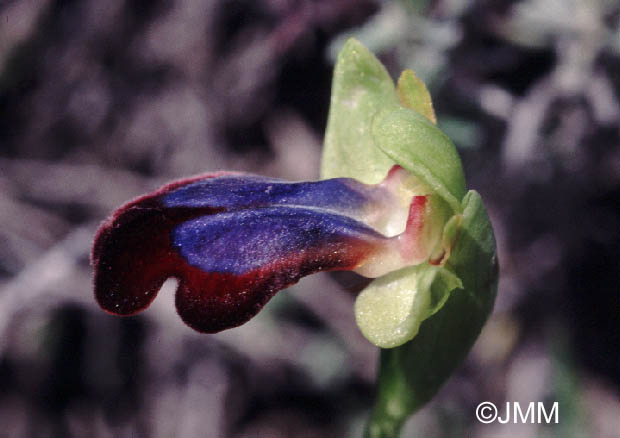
92, 168, 438, 333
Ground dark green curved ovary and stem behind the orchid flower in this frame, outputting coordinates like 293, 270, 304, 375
366, 191, 498, 438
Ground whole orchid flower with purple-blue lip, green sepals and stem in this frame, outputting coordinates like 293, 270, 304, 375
92, 39, 498, 438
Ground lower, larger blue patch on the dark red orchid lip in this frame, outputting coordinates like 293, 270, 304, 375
172, 207, 382, 275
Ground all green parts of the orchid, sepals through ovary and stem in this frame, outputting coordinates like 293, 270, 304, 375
321, 39, 498, 438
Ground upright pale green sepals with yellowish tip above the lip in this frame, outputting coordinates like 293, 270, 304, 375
321, 38, 465, 217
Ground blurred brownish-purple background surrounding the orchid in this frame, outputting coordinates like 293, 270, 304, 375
0, 0, 620, 438
